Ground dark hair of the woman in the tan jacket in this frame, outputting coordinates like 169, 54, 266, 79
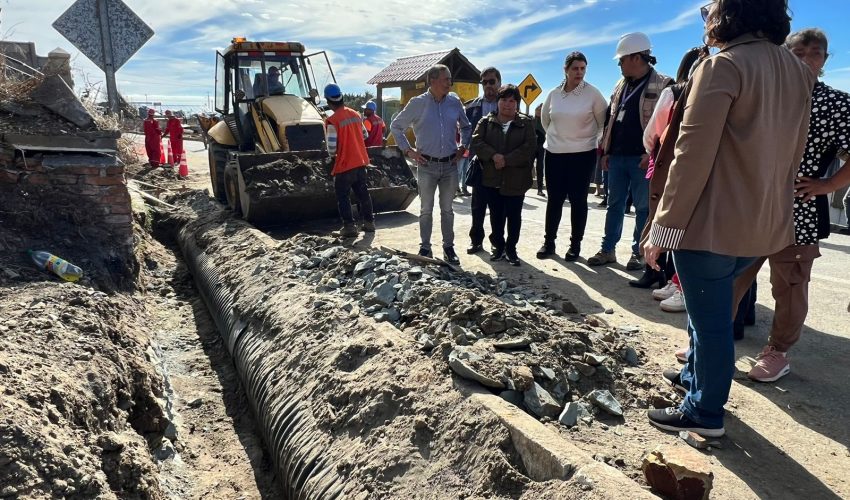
706, 0, 791, 45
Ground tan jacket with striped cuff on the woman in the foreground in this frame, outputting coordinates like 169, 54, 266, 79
649, 34, 815, 257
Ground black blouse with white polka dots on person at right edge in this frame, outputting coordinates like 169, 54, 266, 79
794, 82, 850, 245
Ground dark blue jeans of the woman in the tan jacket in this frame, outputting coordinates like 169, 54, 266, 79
673, 250, 756, 428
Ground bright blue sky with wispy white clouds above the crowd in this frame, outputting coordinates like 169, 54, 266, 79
0, 0, 850, 111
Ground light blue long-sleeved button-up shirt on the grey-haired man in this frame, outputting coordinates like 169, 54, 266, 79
390, 90, 472, 158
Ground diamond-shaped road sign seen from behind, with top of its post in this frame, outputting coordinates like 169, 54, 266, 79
53, 0, 153, 112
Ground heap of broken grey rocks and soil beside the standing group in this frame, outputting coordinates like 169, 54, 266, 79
280, 235, 650, 426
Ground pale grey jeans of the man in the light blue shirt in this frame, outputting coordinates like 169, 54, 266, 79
416, 161, 457, 250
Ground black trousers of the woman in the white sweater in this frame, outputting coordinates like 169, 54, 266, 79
544, 149, 596, 244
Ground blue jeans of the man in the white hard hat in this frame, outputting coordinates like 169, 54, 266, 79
602, 155, 649, 254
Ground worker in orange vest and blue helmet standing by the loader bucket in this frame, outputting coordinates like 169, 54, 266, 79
325, 83, 375, 238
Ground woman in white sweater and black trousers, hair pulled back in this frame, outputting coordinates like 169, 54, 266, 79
537, 52, 607, 261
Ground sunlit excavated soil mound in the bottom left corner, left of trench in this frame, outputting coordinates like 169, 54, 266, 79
0, 258, 168, 499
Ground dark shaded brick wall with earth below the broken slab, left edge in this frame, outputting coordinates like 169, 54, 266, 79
0, 150, 138, 289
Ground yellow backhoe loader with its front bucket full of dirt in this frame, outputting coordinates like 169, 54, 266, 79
207, 38, 416, 225
